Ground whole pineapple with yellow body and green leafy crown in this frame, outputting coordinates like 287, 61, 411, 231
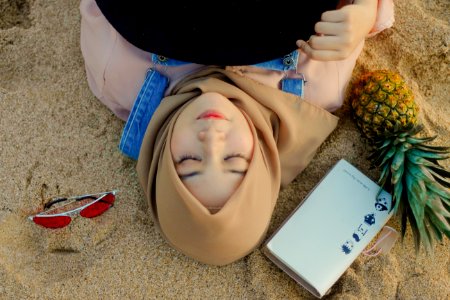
350, 70, 450, 251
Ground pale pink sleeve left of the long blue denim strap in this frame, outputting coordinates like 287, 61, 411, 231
80, 0, 151, 120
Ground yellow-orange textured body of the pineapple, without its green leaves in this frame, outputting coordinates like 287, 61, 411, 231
350, 70, 419, 140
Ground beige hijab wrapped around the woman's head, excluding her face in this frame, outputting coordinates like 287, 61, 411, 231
137, 68, 338, 265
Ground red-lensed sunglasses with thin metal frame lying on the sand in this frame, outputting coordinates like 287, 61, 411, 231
28, 190, 118, 228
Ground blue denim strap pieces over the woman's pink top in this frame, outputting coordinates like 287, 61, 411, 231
119, 51, 305, 160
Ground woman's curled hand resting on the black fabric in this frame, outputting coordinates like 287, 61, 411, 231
297, 0, 378, 61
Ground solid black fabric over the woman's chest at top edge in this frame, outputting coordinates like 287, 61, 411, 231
96, 0, 338, 65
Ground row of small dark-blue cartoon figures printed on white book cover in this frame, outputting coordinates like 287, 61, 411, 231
341, 191, 389, 254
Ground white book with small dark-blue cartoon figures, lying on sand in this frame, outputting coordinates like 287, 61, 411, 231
262, 159, 392, 298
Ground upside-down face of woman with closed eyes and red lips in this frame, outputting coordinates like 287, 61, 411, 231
170, 92, 253, 209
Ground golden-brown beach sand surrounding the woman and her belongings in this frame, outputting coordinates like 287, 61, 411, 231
0, 0, 450, 299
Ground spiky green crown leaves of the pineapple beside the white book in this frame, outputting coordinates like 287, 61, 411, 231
369, 125, 450, 252
